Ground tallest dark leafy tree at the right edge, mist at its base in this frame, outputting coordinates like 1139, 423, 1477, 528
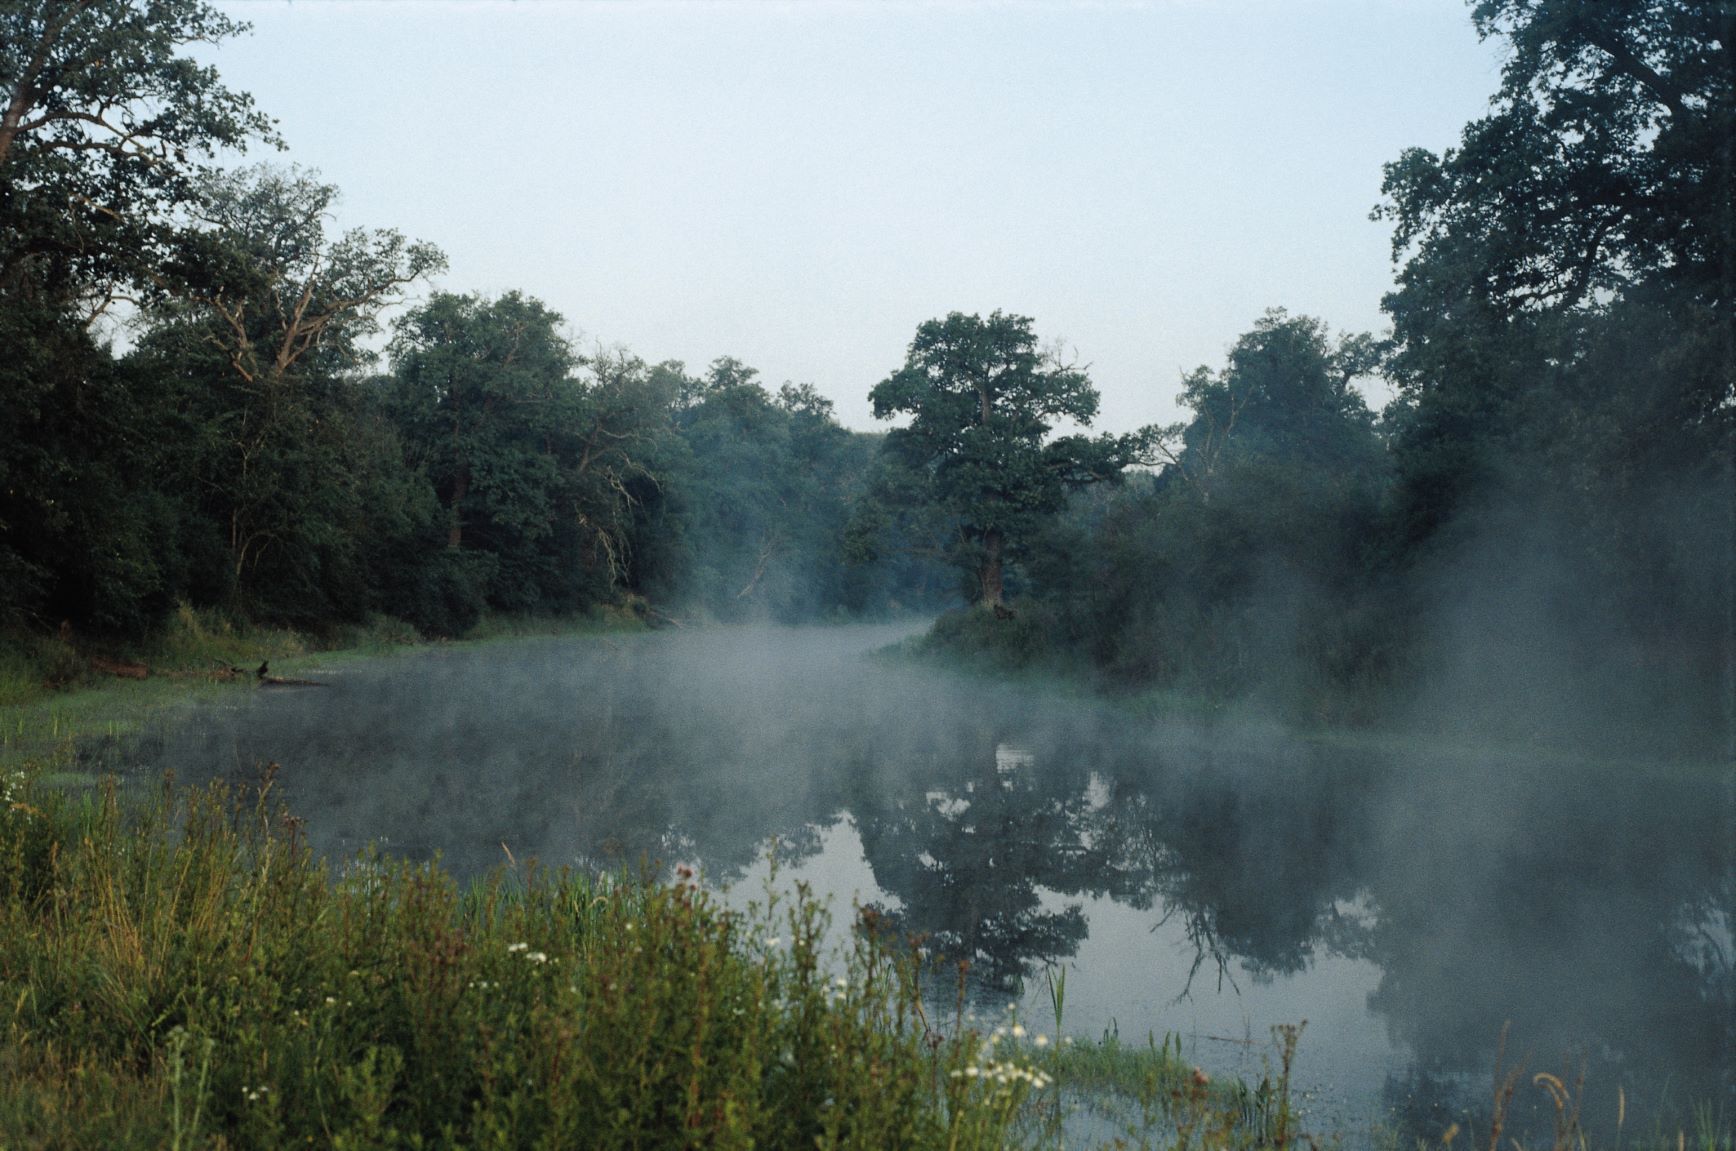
1375, 0, 1736, 731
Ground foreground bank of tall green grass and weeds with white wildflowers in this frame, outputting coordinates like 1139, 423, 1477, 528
0, 756, 1292, 1148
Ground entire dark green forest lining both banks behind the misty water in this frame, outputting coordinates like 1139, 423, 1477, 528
0, 0, 1736, 756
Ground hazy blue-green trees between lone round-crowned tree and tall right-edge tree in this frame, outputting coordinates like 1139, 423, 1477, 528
1021, 311, 1389, 720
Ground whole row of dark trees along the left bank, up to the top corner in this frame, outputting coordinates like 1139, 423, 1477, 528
0, 0, 939, 637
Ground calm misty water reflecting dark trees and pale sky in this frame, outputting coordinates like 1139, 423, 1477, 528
118, 628, 1736, 1141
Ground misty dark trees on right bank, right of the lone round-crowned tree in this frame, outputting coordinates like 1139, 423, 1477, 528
916, 0, 1736, 752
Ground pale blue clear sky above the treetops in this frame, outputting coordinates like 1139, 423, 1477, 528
207, 0, 1500, 431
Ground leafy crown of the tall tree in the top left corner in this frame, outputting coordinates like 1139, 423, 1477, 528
0, 0, 276, 318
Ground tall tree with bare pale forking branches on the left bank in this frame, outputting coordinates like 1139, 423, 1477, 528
146, 167, 444, 611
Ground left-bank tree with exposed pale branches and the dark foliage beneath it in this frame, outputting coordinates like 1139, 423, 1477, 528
135, 168, 443, 627
